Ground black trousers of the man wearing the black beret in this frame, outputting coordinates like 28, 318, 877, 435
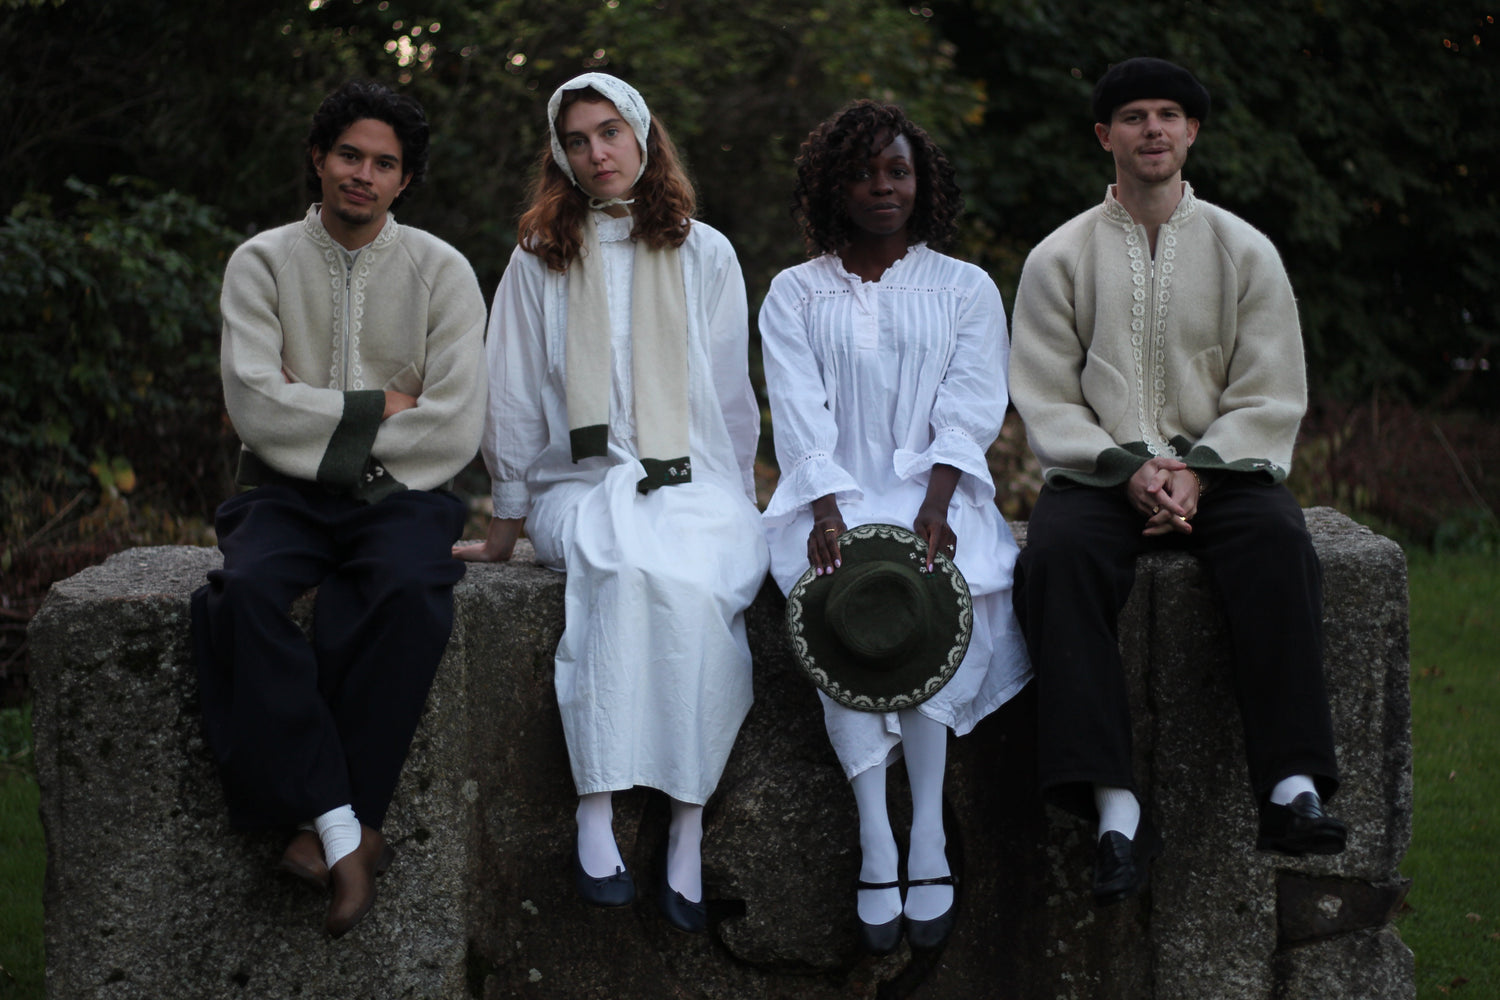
1014, 477, 1338, 817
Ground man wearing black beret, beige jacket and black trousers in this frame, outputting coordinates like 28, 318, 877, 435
1010, 58, 1346, 904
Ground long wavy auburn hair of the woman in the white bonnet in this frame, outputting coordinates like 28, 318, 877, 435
516, 87, 698, 271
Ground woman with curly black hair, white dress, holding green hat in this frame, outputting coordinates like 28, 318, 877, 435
761, 100, 1031, 954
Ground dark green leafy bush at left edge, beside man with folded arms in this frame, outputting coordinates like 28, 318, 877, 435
0, 178, 236, 515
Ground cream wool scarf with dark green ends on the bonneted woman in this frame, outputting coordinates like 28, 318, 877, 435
566, 211, 693, 493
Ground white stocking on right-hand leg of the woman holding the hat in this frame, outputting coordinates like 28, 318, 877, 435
900, 709, 953, 921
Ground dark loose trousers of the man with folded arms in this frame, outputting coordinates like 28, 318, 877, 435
192, 484, 465, 829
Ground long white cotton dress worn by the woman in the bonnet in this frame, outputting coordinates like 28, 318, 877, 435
483, 213, 767, 804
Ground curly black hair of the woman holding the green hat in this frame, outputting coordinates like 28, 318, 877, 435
792, 100, 963, 256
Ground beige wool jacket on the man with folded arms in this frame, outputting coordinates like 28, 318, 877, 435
219, 205, 488, 502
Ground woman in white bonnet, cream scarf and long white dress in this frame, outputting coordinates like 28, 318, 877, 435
455, 73, 768, 931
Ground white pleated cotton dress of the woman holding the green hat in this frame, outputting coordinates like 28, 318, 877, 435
761, 244, 1031, 778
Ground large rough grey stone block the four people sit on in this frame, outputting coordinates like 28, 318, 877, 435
32, 510, 1413, 1000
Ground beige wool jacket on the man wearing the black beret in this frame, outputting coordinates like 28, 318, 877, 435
1010, 183, 1307, 486
